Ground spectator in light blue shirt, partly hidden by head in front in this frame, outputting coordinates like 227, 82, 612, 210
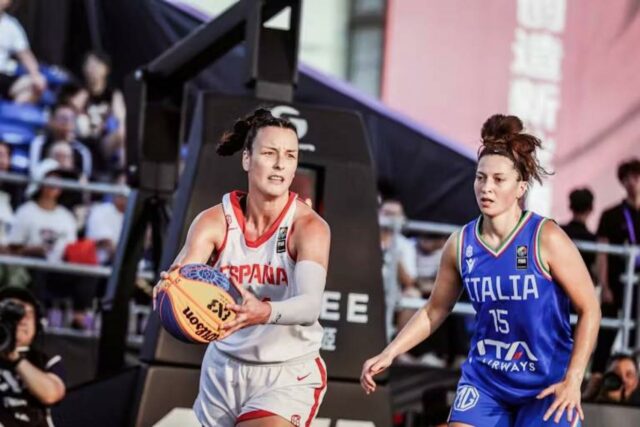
29, 104, 92, 178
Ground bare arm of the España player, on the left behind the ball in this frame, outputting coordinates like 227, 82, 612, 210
153, 205, 226, 310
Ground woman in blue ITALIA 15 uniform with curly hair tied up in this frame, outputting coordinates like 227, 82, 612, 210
360, 115, 600, 427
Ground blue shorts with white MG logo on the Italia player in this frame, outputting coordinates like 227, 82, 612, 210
449, 379, 582, 427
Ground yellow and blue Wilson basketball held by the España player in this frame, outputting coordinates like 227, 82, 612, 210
157, 264, 242, 344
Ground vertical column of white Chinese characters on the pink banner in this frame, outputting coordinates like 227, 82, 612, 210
508, 0, 567, 215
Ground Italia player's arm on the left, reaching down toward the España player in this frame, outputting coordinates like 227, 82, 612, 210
360, 233, 462, 393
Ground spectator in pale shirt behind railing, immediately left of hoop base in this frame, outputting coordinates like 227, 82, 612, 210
87, 171, 127, 265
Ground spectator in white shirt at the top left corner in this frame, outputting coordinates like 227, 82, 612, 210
0, 0, 47, 103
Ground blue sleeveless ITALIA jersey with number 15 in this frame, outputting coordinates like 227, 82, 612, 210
457, 211, 573, 404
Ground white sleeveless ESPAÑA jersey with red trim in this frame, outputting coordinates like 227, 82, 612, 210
212, 191, 322, 363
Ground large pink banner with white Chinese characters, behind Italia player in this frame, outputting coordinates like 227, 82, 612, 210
383, 0, 640, 226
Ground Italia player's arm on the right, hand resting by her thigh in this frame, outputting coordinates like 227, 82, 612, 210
538, 221, 601, 422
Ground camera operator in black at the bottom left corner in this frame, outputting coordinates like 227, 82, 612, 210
0, 287, 65, 427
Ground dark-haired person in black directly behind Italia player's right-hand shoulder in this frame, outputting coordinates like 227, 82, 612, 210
562, 188, 596, 272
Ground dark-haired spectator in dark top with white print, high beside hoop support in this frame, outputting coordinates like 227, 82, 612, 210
82, 52, 125, 181
